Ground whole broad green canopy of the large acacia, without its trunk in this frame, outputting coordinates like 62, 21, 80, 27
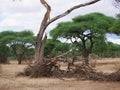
50, 13, 115, 39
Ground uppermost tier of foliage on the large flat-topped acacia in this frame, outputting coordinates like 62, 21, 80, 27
73, 13, 115, 30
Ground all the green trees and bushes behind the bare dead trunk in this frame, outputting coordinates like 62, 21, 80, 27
0, 13, 120, 64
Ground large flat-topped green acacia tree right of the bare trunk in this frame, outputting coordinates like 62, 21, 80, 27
51, 13, 114, 64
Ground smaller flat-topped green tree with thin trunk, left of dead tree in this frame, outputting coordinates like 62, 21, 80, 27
0, 31, 35, 64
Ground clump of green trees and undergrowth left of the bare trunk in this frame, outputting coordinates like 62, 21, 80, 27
0, 30, 35, 64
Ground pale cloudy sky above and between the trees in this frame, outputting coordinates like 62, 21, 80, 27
0, 0, 120, 44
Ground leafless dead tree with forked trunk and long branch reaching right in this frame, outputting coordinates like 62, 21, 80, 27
35, 0, 100, 63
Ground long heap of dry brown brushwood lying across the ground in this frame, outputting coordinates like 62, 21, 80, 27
19, 62, 120, 81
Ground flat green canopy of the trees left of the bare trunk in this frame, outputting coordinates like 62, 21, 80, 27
0, 30, 35, 44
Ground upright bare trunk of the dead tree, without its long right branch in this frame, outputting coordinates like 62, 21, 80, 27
35, 0, 51, 62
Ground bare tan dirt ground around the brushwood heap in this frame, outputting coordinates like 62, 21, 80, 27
0, 58, 120, 90
